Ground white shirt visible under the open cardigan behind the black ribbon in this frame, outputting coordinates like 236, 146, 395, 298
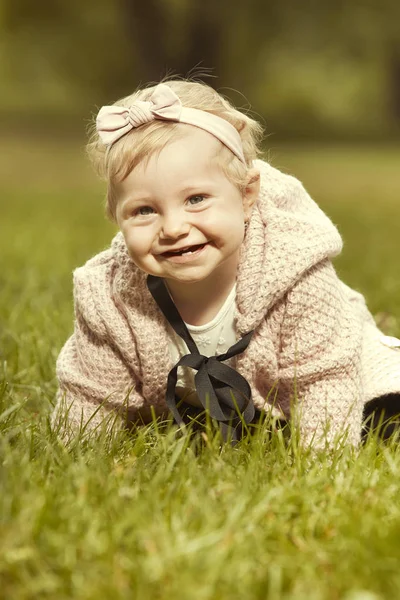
168, 284, 237, 406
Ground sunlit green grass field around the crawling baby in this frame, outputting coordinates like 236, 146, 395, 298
0, 138, 400, 600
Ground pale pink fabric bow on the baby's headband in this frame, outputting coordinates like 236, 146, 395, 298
96, 83, 182, 146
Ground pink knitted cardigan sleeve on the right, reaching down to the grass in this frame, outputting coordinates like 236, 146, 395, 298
279, 260, 364, 448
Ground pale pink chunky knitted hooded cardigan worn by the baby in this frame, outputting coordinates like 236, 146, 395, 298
53, 161, 400, 445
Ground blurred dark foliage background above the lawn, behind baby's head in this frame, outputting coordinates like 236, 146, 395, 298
0, 0, 400, 140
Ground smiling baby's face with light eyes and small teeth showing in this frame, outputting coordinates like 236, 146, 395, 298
117, 126, 258, 285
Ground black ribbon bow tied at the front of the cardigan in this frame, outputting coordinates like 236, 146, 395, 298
147, 275, 255, 441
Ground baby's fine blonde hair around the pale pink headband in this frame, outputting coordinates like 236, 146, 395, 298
87, 79, 263, 221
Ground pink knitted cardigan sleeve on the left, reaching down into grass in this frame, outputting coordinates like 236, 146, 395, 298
51, 272, 164, 440
